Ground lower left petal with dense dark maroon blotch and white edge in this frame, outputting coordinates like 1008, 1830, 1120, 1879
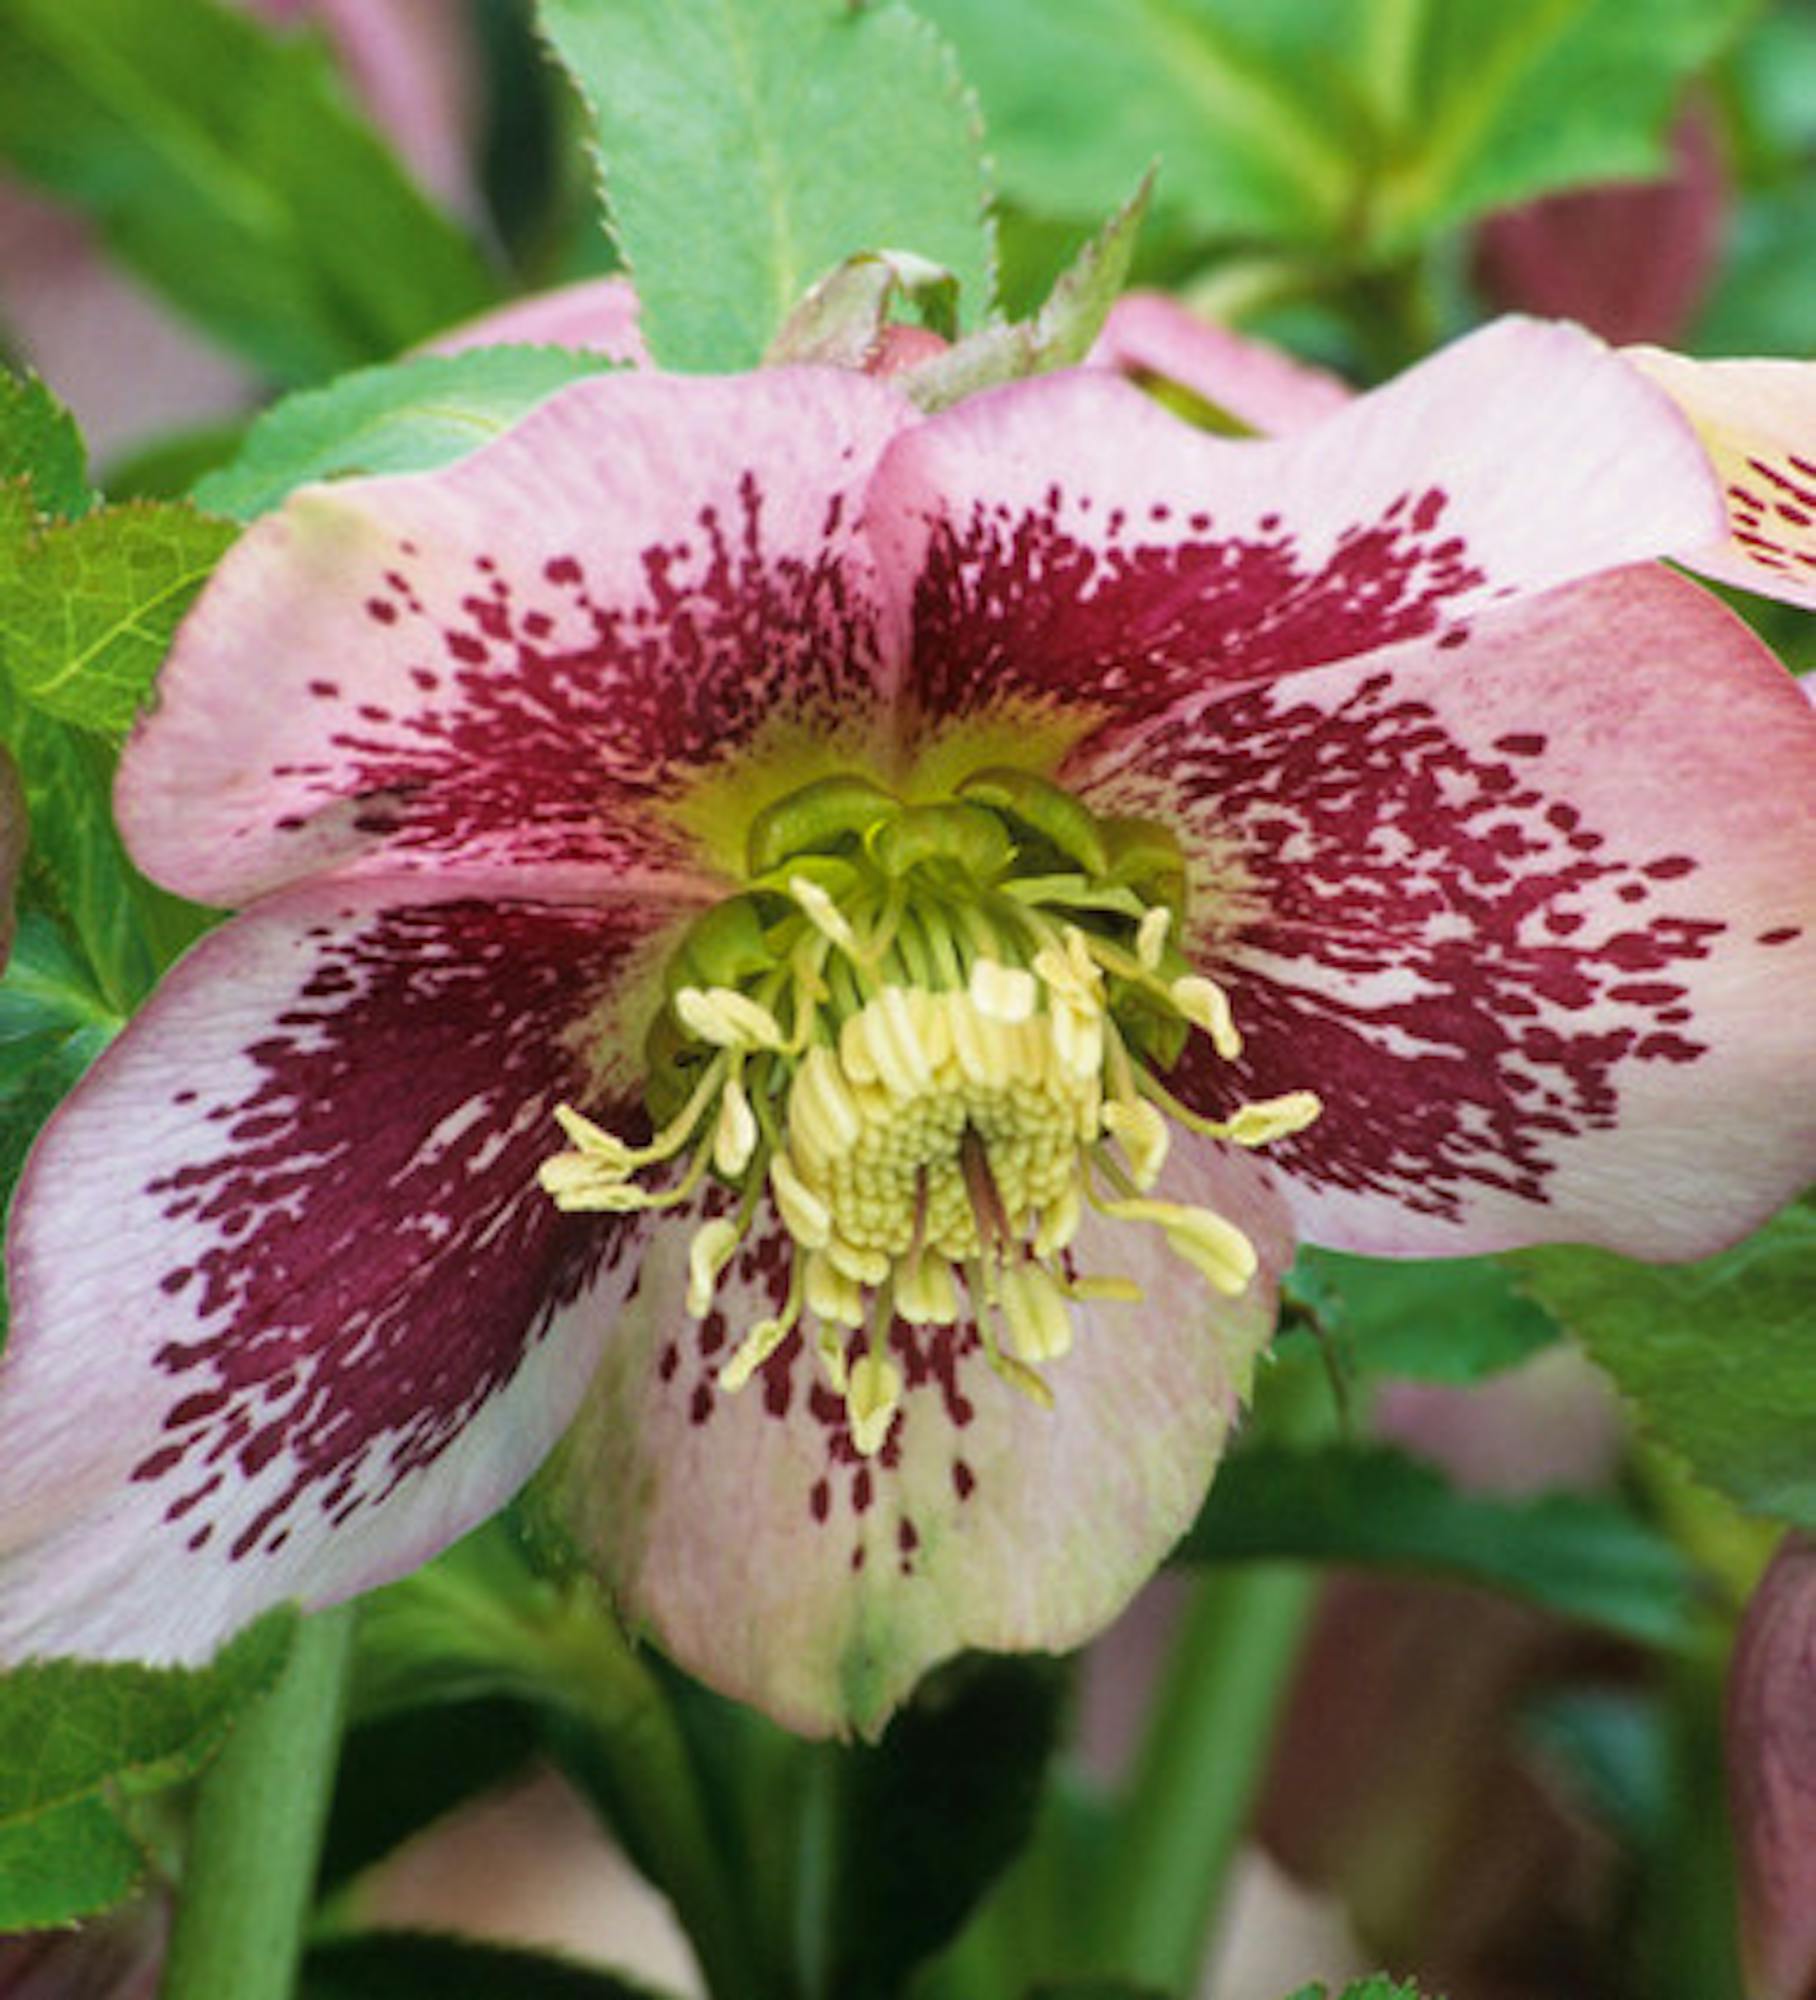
0, 882, 670, 1660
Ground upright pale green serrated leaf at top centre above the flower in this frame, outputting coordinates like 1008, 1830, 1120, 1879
538, 0, 992, 370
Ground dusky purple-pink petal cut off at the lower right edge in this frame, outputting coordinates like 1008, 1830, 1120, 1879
1728, 1534, 1816, 2000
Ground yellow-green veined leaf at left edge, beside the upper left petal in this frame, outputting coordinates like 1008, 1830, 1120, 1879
0, 500, 236, 732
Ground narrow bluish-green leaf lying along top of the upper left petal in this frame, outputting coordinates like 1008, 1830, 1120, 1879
194, 346, 618, 522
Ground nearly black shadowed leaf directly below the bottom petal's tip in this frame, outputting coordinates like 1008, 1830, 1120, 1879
828, 1658, 1066, 1996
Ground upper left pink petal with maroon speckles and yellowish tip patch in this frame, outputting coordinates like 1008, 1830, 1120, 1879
118, 370, 914, 904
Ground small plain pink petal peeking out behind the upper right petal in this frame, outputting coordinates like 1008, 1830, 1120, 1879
1088, 292, 1356, 436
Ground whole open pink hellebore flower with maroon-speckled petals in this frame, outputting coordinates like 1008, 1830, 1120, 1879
0, 324, 1816, 1730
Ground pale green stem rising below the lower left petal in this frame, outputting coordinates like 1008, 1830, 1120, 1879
158, 1608, 354, 2000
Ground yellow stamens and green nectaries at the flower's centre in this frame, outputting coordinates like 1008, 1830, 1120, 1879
540, 768, 1318, 1454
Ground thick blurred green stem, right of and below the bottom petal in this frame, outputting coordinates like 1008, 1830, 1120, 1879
1102, 1564, 1318, 1992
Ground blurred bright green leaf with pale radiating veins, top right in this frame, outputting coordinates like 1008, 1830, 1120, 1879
922, 0, 1752, 262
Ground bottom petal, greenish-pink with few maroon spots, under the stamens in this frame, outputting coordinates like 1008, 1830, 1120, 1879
532, 1148, 1292, 1736
